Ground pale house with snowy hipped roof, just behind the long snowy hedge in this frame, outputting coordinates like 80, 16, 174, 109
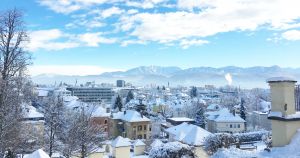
206, 108, 246, 133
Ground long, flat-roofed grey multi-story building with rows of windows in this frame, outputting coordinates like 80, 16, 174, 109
67, 87, 114, 103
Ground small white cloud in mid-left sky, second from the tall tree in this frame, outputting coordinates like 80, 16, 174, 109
79, 33, 117, 47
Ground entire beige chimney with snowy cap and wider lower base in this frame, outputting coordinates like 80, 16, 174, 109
267, 77, 300, 147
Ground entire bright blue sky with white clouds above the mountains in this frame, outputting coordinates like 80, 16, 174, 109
0, 0, 300, 75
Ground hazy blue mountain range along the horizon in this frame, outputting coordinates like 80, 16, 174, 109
32, 66, 300, 88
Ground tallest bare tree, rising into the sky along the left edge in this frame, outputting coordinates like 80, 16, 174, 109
0, 9, 30, 157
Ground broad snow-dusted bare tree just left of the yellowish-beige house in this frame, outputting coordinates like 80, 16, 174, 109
64, 105, 105, 158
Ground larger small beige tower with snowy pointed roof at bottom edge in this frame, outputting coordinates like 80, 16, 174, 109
111, 136, 131, 158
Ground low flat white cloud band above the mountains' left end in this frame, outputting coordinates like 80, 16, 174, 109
28, 65, 122, 76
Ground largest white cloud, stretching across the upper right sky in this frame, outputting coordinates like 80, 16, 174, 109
119, 0, 300, 43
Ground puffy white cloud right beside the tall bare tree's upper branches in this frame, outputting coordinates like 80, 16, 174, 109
26, 29, 79, 51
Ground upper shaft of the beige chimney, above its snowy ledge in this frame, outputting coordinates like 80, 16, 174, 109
267, 77, 297, 116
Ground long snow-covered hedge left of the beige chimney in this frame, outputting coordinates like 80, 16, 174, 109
204, 131, 269, 154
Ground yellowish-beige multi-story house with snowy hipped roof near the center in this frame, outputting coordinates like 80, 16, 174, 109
109, 110, 151, 139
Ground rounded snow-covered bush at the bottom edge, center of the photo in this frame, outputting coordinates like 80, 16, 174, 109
149, 142, 195, 158
